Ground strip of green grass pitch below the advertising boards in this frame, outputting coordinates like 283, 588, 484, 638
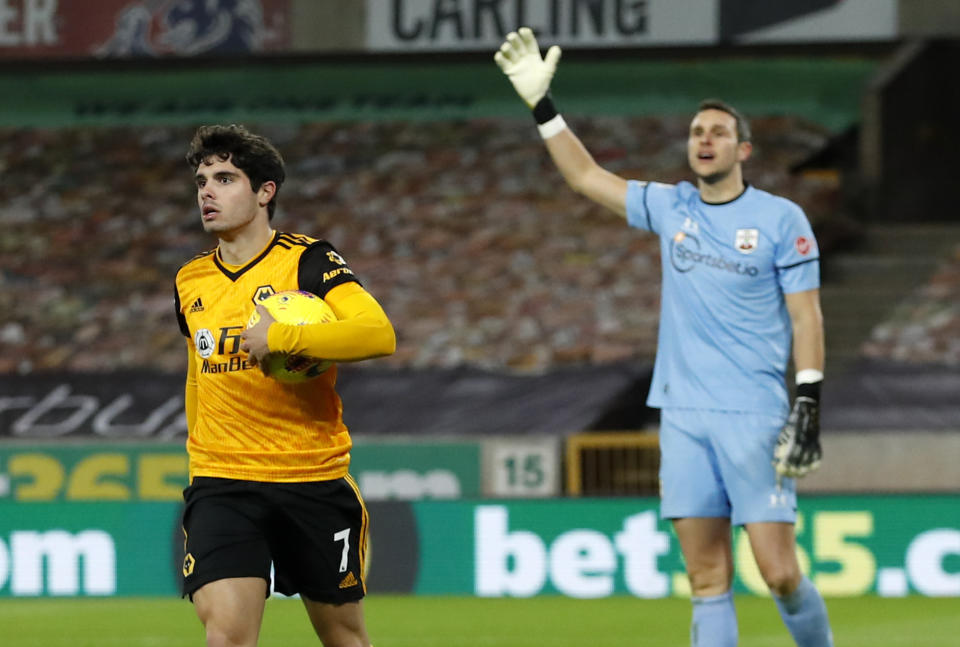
0, 595, 960, 647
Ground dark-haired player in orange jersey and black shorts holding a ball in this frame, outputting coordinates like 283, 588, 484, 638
175, 125, 396, 647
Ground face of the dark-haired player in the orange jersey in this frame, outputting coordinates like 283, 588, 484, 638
195, 156, 273, 234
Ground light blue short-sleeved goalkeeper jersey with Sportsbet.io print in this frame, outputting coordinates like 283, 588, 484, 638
626, 181, 820, 414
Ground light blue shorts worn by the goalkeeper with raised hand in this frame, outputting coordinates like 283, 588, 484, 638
660, 408, 797, 526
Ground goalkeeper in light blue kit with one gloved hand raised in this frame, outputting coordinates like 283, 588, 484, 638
494, 28, 833, 647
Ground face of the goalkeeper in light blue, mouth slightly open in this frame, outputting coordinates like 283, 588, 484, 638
687, 108, 750, 184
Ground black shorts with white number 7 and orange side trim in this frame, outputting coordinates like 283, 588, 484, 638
183, 476, 368, 604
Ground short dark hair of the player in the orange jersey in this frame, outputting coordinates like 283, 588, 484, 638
187, 124, 286, 220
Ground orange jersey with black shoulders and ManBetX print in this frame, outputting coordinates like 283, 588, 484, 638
175, 232, 358, 482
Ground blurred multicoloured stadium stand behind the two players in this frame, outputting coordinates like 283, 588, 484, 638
0, 117, 960, 373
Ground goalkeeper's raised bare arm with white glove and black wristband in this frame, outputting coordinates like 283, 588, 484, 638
493, 27, 627, 217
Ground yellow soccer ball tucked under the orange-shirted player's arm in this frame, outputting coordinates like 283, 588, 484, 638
247, 290, 337, 384
